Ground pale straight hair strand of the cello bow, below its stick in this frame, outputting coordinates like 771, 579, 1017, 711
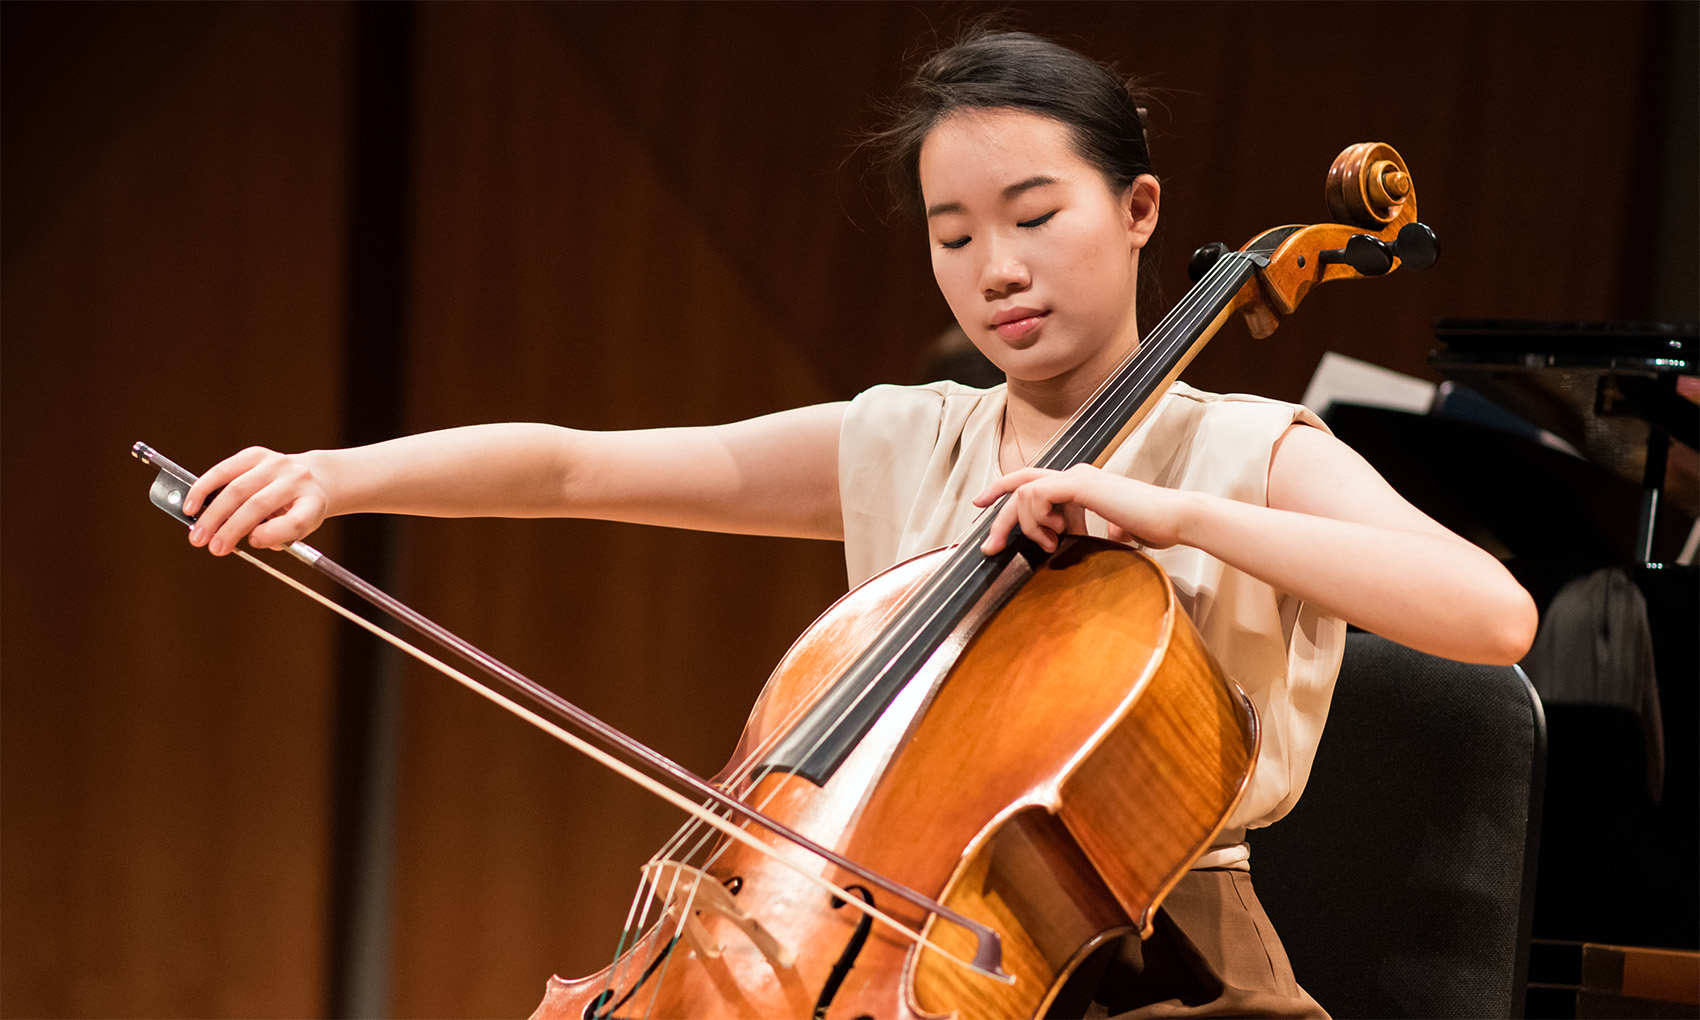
231, 549, 992, 981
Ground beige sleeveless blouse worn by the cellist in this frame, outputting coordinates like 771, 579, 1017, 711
838, 383, 1346, 856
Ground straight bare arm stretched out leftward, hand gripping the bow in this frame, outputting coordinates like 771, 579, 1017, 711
184, 403, 845, 556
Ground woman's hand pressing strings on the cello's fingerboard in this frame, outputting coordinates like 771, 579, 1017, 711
974, 464, 1187, 556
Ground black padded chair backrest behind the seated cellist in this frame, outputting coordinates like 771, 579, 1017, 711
1251, 634, 1545, 1017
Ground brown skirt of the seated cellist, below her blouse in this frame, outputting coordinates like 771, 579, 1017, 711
1051, 869, 1328, 1020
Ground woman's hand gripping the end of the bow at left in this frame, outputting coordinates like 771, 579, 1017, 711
184, 447, 330, 556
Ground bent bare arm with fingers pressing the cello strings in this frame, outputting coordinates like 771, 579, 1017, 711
976, 425, 1537, 663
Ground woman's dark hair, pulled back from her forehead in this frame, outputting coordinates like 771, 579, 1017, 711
869, 29, 1153, 216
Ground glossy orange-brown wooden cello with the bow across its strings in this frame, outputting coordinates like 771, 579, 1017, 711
138, 145, 1435, 1017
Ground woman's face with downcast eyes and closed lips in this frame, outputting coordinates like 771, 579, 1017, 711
920, 109, 1158, 386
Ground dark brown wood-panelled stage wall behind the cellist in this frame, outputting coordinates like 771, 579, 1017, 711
0, 3, 1695, 1017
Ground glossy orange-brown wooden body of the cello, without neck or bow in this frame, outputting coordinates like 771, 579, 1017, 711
534, 539, 1256, 1018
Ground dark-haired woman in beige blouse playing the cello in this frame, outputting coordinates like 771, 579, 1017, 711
184, 27, 1535, 1017
